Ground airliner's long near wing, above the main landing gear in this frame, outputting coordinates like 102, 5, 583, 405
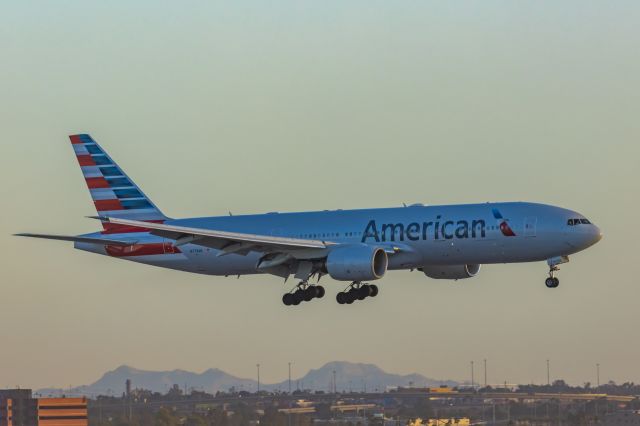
101, 217, 334, 255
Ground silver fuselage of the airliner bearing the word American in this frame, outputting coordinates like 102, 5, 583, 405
75, 202, 601, 275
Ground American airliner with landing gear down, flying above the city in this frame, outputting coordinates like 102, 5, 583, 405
15, 134, 602, 306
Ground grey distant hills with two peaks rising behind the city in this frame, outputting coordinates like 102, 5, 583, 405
37, 361, 458, 397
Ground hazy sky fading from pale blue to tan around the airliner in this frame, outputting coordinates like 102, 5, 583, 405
0, 0, 640, 387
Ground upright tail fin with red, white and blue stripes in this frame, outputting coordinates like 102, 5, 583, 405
69, 134, 167, 231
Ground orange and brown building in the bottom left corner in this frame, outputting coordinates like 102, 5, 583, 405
0, 389, 89, 426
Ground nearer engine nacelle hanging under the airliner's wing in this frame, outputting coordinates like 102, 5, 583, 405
326, 244, 389, 281
